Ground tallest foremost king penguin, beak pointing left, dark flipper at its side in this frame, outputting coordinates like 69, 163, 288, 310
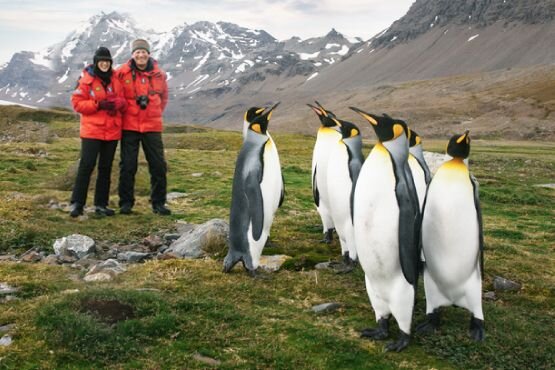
351, 107, 420, 351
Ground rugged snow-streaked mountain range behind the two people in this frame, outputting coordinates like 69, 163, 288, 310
0, 12, 361, 118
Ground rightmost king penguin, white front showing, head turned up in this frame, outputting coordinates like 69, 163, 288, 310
417, 131, 484, 341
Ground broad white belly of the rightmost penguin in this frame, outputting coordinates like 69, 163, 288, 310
422, 165, 480, 303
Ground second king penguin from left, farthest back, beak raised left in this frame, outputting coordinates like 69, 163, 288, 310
307, 102, 341, 243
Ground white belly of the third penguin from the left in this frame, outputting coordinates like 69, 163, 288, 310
327, 141, 357, 260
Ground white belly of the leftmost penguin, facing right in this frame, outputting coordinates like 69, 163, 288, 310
248, 139, 283, 269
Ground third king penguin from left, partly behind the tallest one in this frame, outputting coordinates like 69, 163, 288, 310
327, 120, 364, 271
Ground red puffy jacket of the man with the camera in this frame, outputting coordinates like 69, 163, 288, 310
116, 58, 168, 132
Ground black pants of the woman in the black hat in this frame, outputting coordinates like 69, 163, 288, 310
71, 139, 118, 207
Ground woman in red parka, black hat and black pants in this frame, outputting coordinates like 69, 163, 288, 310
70, 46, 127, 217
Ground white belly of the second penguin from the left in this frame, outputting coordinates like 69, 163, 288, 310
312, 127, 341, 232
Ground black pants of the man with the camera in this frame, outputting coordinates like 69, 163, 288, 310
119, 130, 168, 207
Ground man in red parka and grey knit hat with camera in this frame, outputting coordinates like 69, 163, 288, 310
116, 39, 171, 215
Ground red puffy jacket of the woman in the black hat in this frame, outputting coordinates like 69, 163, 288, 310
71, 65, 127, 140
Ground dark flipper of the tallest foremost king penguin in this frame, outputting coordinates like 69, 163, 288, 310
393, 162, 421, 287
